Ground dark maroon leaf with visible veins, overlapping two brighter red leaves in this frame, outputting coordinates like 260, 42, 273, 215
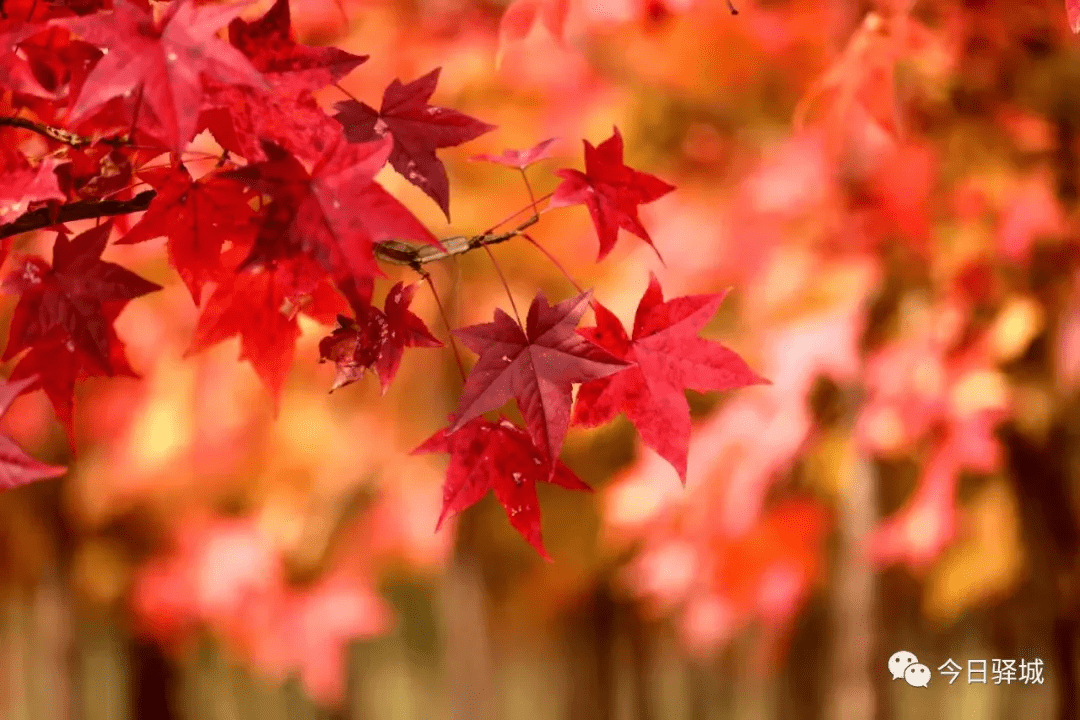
450, 291, 630, 473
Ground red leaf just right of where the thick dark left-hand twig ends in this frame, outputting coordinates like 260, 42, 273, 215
117, 165, 255, 305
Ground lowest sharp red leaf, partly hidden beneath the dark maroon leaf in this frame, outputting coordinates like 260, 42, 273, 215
413, 418, 592, 560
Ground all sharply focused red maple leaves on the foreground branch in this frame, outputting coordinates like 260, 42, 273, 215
0, 0, 761, 555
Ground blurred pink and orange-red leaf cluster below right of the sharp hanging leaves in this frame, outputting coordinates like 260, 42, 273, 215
605, 306, 860, 660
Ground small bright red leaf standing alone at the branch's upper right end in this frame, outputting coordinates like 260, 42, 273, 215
548, 127, 675, 260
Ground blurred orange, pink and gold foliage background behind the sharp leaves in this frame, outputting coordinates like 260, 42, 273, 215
0, 0, 1080, 720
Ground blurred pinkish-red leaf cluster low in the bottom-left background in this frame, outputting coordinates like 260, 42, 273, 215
133, 517, 391, 705
